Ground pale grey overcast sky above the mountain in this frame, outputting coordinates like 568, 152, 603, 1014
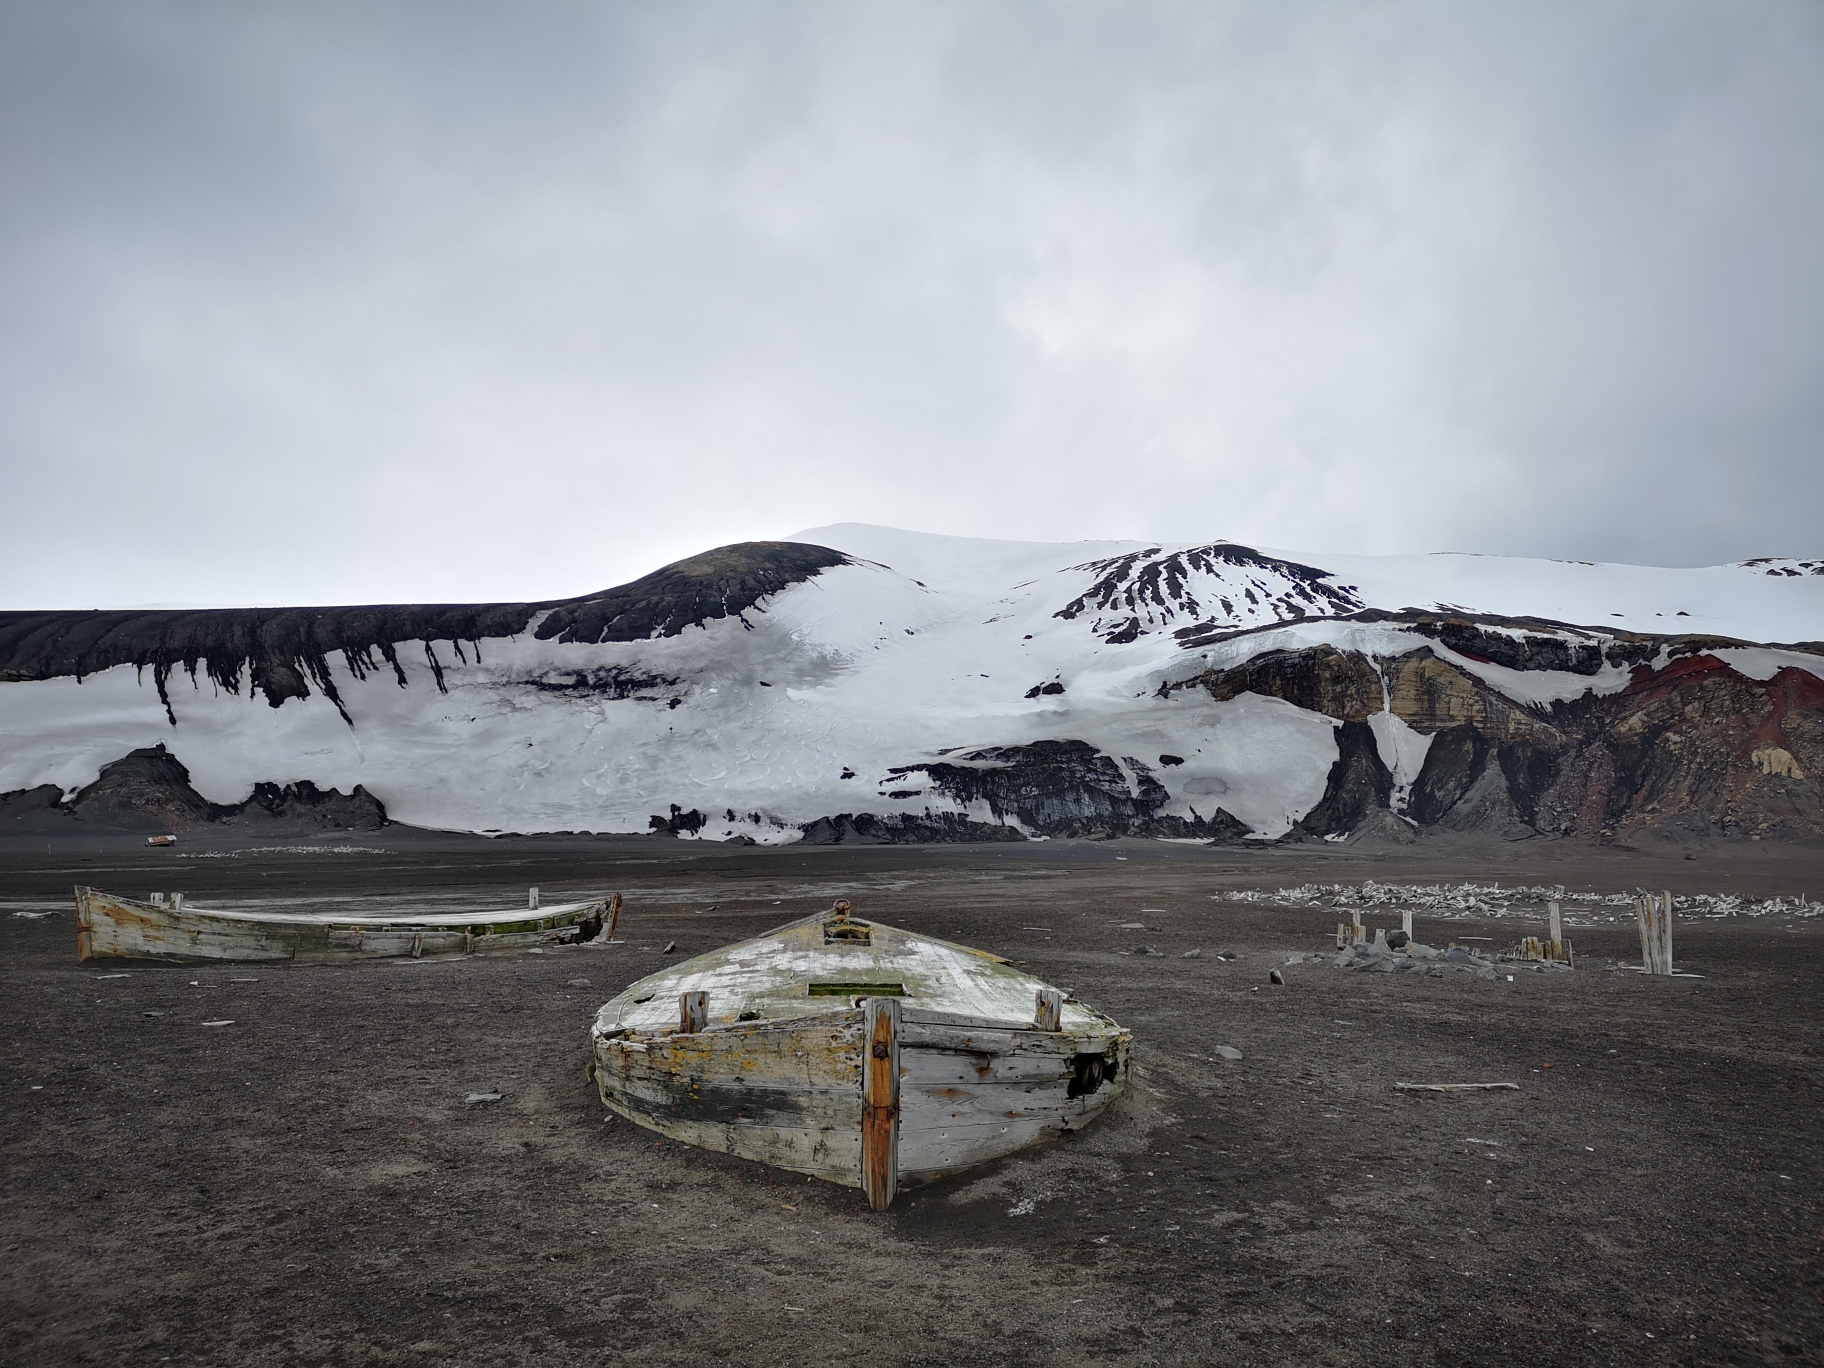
0, 0, 1824, 607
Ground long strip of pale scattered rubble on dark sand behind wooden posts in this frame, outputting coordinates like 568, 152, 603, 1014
1211, 879, 1824, 927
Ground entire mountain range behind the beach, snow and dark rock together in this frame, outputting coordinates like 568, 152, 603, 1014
0, 525, 1824, 843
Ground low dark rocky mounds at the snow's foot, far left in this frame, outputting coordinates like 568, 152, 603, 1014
0, 744, 390, 835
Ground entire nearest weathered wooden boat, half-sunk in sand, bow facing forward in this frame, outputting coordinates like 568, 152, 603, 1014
589, 903, 1131, 1209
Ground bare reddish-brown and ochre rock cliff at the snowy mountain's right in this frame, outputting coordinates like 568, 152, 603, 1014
1200, 646, 1824, 839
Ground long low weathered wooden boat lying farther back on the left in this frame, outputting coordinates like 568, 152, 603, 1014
77, 888, 620, 963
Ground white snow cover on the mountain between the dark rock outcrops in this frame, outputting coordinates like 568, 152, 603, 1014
0, 523, 1824, 841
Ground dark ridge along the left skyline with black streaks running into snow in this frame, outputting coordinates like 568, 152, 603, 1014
0, 542, 848, 726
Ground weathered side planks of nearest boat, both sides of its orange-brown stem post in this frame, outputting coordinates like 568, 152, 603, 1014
589, 1005, 1131, 1189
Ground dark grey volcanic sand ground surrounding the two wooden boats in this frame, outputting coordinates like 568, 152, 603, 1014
0, 842, 1824, 1364
